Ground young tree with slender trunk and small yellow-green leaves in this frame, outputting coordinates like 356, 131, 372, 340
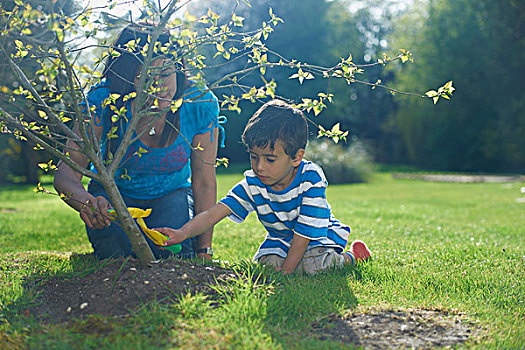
0, 0, 453, 266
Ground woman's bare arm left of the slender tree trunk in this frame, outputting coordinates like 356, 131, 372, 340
53, 124, 111, 228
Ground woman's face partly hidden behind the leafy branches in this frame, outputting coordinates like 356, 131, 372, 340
134, 58, 177, 109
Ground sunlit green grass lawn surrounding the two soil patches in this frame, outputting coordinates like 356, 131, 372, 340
0, 173, 525, 349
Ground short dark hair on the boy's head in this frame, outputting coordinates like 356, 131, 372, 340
242, 100, 308, 157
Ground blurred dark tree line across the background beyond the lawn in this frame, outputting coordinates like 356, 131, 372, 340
0, 0, 525, 186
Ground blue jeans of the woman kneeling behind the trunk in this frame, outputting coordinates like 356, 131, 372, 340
86, 182, 197, 260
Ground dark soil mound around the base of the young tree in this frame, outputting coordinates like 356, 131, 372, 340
27, 259, 236, 323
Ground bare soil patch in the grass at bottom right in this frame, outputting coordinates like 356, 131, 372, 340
313, 309, 479, 349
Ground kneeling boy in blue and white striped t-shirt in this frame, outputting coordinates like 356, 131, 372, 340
157, 100, 370, 274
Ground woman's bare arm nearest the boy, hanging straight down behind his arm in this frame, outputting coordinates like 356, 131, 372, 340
191, 128, 219, 259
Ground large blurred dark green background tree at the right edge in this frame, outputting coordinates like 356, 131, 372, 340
388, 0, 525, 172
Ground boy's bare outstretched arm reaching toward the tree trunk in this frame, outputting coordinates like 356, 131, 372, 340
155, 203, 231, 246
